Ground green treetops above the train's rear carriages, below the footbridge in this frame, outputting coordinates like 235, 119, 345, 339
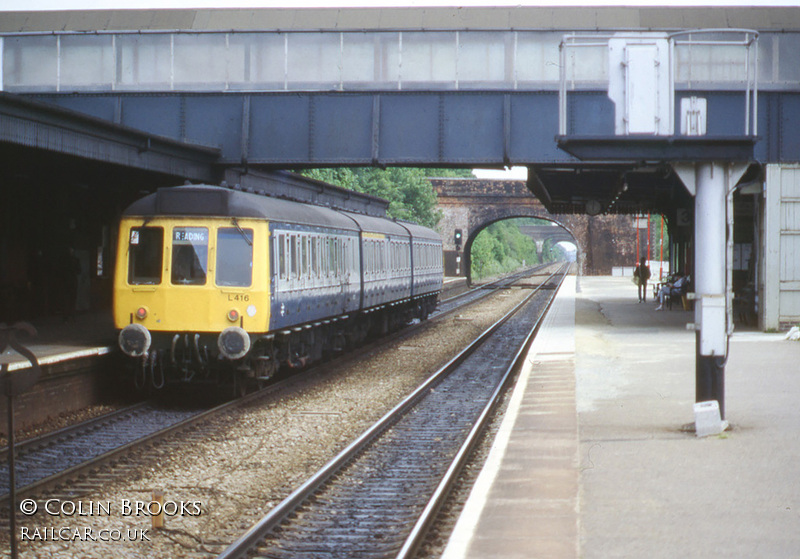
302, 167, 470, 227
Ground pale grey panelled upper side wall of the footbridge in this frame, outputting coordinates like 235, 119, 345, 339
0, 30, 764, 97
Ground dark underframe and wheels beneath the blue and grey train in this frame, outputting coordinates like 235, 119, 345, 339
126, 293, 438, 396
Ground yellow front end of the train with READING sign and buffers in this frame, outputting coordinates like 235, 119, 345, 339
114, 216, 270, 388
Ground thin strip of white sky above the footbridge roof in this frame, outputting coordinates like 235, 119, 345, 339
0, 0, 800, 11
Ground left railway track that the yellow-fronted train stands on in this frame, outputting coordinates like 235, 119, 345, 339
0, 271, 552, 514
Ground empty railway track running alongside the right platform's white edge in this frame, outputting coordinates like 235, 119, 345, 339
219, 264, 565, 559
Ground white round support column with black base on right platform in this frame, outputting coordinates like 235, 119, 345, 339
675, 162, 747, 419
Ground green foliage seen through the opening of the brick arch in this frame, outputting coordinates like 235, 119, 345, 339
470, 219, 550, 279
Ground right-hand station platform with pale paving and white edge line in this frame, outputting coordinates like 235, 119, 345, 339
444, 277, 800, 559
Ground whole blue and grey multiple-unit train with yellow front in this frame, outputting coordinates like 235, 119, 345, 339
113, 185, 443, 392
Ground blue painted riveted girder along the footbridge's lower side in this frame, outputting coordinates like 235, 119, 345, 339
32, 91, 800, 168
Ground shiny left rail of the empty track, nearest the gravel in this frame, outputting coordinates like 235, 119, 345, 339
217, 264, 558, 559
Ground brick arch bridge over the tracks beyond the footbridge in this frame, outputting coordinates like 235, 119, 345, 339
429, 178, 636, 277
